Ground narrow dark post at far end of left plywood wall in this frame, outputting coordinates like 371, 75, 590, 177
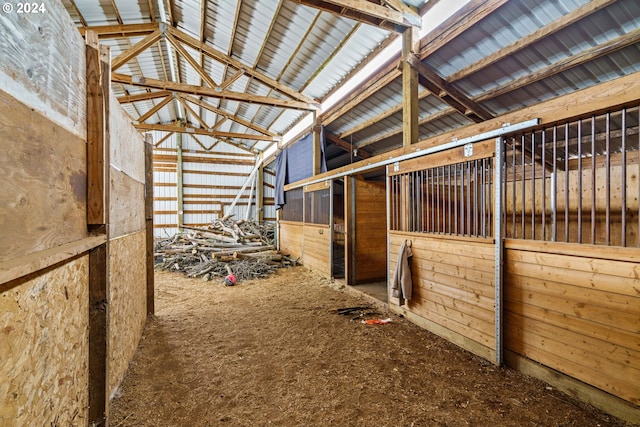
144, 133, 156, 316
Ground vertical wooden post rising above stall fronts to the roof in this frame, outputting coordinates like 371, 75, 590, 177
402, 28, 420, 147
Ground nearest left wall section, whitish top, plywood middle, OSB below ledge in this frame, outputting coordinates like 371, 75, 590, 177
0, 2, 91, 427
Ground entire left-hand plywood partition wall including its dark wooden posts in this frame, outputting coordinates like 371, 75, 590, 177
0, 2, 153, 426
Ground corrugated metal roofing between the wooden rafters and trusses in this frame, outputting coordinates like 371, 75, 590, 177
63, 0, 640, 171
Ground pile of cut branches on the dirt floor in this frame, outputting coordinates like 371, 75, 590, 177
154, 220, 296, 280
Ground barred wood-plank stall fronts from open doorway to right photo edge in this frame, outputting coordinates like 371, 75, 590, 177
387, 101, 640, 419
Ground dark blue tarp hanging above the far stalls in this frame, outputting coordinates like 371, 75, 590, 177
275, 128, 327, 209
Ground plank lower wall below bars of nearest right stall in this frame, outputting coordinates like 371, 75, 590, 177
504, 240, 640, 405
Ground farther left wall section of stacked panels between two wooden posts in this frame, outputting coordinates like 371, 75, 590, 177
108, 92, 147, 395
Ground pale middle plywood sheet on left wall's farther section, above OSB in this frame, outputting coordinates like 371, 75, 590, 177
109, 166, 145, 239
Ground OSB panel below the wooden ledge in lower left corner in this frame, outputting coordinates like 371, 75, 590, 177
0, 256, 89, 427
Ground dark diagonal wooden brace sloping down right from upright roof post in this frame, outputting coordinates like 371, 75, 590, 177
405, 55, 493, 123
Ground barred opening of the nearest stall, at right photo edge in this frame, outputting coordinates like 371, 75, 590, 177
503, 107, 640, 247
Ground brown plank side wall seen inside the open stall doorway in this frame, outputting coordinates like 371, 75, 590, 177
347, 178, 387, 284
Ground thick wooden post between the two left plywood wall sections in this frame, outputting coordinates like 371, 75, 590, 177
85, 32, 111, 426
